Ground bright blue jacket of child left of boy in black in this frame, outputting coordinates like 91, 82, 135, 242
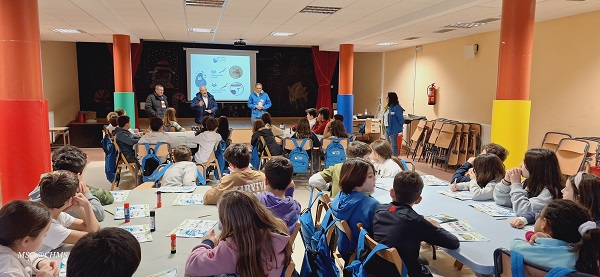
331, 191, 379, 259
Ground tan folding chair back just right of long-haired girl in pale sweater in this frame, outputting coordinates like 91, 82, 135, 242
556, 138, 590, 176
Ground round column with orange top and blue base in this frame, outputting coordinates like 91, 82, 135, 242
337, 44, 354, 133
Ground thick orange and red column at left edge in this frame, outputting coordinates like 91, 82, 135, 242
0, 0, 50, 204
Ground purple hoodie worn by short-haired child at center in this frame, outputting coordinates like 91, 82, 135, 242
256, 187, 302, 235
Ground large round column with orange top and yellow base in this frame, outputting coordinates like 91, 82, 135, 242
492, 0, 536, 168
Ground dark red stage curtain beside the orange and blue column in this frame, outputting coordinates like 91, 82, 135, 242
312, 46, 339, 112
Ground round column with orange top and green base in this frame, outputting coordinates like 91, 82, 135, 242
113, 35, 136, 126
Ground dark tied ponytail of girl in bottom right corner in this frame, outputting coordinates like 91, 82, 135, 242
574, 221, 600, 276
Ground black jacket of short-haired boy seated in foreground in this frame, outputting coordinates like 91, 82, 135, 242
370, 202, 460, 277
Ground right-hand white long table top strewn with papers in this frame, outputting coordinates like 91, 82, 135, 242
371, 178, 525, 275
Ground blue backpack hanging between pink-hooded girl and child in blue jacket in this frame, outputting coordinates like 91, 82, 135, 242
300, 209, 339, 277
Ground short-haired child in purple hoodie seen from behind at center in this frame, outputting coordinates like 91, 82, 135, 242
256, 157, 301, 234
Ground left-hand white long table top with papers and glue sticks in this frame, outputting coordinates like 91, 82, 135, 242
82, 186, 219, 277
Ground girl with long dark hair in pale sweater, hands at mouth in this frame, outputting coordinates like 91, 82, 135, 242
494, 149, 565, 216
